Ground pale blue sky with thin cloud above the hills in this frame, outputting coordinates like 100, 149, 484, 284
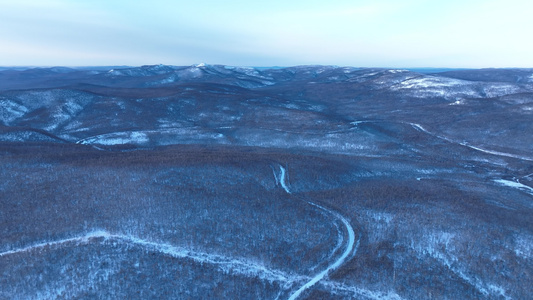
0, 0, 533, 68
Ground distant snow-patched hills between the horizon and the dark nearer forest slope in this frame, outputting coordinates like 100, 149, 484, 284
0, 64, 533, 157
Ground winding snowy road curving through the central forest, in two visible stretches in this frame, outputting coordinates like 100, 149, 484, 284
279, 166, 359, 300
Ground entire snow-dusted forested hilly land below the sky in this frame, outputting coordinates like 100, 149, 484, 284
0, 64, 533, 299
